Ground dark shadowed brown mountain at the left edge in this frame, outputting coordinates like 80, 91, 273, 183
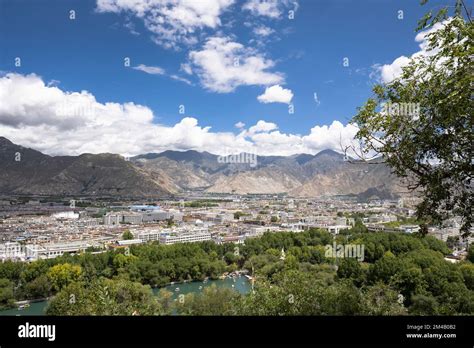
0, 137, 170, 197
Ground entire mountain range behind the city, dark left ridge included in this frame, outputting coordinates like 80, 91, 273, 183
0, 137, 403, 199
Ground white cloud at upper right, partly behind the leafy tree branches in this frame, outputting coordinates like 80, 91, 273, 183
378, 20, 450, 83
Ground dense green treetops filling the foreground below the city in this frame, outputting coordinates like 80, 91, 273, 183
0, 226, 474, 315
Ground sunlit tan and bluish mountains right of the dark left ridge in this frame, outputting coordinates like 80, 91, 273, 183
133, 150, 401, 197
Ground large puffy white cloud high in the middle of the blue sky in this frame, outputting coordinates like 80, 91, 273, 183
189, 37, 284, 93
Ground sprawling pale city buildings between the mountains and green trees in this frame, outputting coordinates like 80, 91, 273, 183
0, 196, 468, 261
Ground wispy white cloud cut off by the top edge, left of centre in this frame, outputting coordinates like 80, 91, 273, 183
97, 0, 234, 48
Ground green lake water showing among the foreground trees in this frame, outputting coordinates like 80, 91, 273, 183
0, 277, 251, 316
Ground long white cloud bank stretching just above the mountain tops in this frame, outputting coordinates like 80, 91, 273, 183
0, 73, 357, 156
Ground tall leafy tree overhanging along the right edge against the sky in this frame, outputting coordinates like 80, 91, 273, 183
346, 0, 474, 236
